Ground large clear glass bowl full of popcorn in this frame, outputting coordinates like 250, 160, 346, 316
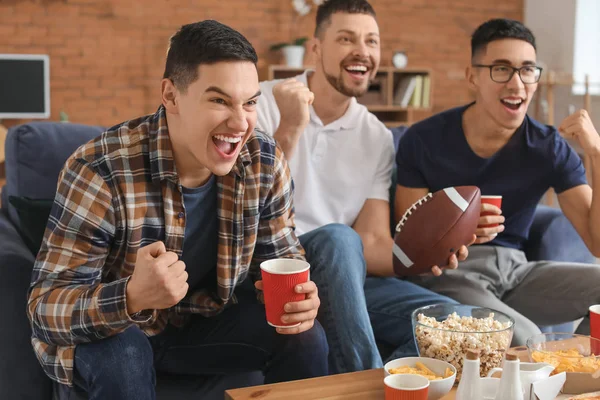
412, 304, 515, 382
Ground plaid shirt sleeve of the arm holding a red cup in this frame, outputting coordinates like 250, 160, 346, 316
250, 146, 304, 280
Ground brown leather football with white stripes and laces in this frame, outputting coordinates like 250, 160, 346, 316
393, 186, 481, 276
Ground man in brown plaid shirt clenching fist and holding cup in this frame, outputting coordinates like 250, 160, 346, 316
28, 21, 328, 400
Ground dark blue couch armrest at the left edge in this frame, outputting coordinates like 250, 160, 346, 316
0, 212, 52, 400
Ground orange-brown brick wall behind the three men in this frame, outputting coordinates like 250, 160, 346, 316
0, 0, 523, 125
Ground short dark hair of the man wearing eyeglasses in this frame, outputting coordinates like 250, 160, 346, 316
471, 18, 535, 58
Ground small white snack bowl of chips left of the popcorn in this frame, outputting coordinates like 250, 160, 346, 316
383, 357, 456, 400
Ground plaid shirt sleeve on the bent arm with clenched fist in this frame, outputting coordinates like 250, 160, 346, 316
27, 157, 150, 345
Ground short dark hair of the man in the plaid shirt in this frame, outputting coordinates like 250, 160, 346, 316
163, 20, 258, 92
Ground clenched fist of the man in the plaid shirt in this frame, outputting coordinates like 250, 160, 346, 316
126, 242, 188, 315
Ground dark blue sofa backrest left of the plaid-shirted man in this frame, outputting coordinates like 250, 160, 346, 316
2, 122, 104, 227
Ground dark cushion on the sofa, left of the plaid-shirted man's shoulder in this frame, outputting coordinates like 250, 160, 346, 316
8, 196, 54, 254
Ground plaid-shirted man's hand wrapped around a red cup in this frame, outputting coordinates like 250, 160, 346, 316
254, 281, 321, 335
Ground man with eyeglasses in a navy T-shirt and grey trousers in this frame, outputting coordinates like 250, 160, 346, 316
395, 19, 600, 345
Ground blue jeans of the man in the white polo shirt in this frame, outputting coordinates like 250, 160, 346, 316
300, 224, 456, 373
